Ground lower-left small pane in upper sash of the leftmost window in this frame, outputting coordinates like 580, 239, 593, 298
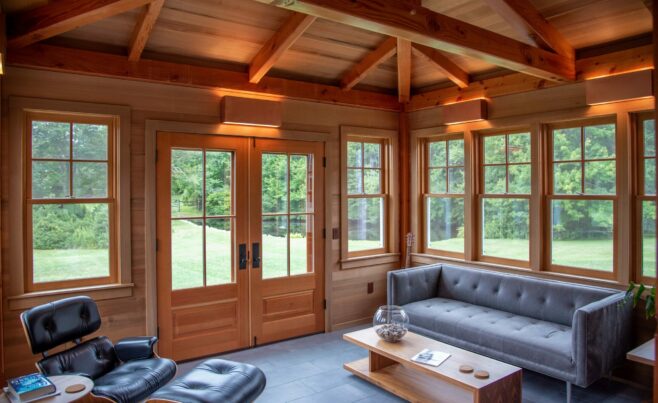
32, 161, 71, 199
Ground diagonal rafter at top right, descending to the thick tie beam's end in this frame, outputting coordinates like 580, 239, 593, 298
485, 0, 574, 59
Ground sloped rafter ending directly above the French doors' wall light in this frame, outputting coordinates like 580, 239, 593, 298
249, 13, 316, 84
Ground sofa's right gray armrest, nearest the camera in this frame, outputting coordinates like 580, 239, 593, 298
572, 292, 633, 387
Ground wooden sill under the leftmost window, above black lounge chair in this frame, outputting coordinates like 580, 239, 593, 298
7, 283, 135, 311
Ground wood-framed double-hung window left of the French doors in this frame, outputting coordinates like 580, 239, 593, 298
25, 112, 117, 291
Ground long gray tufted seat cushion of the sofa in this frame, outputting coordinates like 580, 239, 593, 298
404, 298, 575, 371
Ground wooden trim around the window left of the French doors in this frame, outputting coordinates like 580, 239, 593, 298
6, 97, 134, 309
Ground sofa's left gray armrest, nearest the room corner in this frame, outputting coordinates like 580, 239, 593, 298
387, 264, 441, 305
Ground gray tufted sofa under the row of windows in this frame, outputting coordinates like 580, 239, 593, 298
388, 264, 632, 392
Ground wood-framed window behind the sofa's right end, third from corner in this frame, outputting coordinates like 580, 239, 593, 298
548, 121, 617, 277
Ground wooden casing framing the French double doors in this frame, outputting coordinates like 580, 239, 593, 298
144, 119, 332, 336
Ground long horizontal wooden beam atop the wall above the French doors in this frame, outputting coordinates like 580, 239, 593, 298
7, 44, 400, 111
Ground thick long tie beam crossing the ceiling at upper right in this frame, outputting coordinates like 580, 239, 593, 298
252, 0, 575, 81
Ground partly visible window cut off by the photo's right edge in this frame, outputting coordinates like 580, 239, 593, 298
638, 115, 656, 277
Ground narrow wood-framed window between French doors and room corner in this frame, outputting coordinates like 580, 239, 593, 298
346, 136, 387, 256
